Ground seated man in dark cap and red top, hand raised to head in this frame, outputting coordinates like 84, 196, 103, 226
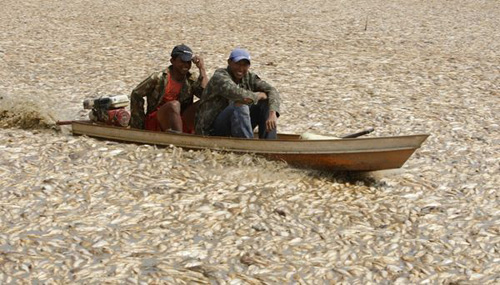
130, 44, 208, 133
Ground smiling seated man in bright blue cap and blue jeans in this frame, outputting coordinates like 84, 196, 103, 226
195, 48, 280, 139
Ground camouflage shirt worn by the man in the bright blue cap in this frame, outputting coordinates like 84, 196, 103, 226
195, 67, 280, 135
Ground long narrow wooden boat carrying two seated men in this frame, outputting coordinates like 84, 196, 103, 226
71, 122, 429, 171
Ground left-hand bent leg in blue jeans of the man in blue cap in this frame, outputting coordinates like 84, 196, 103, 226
214, 103, 253, 138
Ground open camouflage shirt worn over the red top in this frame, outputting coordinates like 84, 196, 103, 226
130, 66, 203, 129
